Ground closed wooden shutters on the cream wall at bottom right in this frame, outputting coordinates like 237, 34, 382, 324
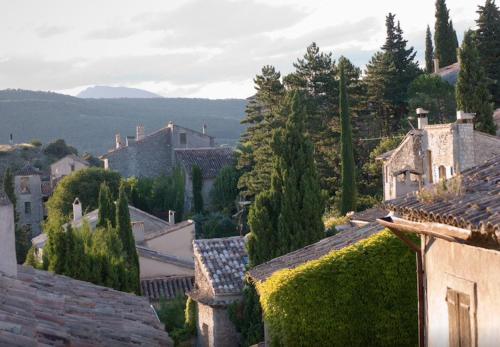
446, 288, 472, 347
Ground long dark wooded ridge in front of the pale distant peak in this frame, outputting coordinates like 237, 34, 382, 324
0, 89, 247, 155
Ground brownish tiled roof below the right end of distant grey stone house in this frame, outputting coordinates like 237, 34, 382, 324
175, 147, 234, 178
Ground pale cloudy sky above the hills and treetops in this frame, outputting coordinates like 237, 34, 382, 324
0, 0, 484, 99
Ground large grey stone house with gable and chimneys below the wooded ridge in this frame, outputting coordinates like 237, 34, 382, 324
101, 122, 215, 177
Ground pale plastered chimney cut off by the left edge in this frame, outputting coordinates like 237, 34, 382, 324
0, 190, 17, 277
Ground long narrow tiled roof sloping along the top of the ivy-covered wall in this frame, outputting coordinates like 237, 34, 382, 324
248, 223, 384, 281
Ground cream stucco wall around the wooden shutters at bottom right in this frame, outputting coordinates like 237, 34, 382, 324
423, 238, 500, 346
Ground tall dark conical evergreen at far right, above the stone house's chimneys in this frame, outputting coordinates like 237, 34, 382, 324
456, 30, 496, 134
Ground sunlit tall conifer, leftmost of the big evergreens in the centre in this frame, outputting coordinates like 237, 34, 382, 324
237, 65, 285, 199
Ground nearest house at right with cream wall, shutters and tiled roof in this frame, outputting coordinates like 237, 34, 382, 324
379, 156, 500, 347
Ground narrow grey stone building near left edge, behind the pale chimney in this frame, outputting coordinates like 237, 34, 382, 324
14, 164, 44, 237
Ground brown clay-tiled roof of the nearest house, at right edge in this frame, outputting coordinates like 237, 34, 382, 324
385, 156, 500, 243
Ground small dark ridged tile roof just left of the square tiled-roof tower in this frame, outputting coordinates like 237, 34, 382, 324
141, 276, 194, 302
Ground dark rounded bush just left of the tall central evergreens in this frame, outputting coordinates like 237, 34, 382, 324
210, 166, 240, 214
